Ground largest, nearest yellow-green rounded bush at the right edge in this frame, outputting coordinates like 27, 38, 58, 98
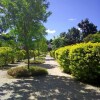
69, 43, 100, 82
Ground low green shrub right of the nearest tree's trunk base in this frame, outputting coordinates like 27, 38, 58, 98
29, 66, 48, 76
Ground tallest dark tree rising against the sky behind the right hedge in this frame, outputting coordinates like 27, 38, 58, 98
78, 19, 97, 38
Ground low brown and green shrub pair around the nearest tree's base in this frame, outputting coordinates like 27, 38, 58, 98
7, 66, 48, 78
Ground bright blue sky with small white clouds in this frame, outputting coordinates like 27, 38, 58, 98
44, 0, 100, 40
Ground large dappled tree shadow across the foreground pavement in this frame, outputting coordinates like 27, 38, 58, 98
0, 75, 100, 100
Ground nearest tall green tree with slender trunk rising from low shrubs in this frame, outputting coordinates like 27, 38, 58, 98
0, 0, 51, 68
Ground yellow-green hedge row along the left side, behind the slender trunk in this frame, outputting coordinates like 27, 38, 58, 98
0, 47, 41, 66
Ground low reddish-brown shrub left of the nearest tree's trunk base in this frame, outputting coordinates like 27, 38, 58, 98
7, 67, 30, 77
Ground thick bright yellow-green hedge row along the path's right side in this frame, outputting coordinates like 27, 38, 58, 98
53, 43, 100, 83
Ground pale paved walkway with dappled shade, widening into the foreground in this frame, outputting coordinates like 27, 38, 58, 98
0, 56, 100, 100
